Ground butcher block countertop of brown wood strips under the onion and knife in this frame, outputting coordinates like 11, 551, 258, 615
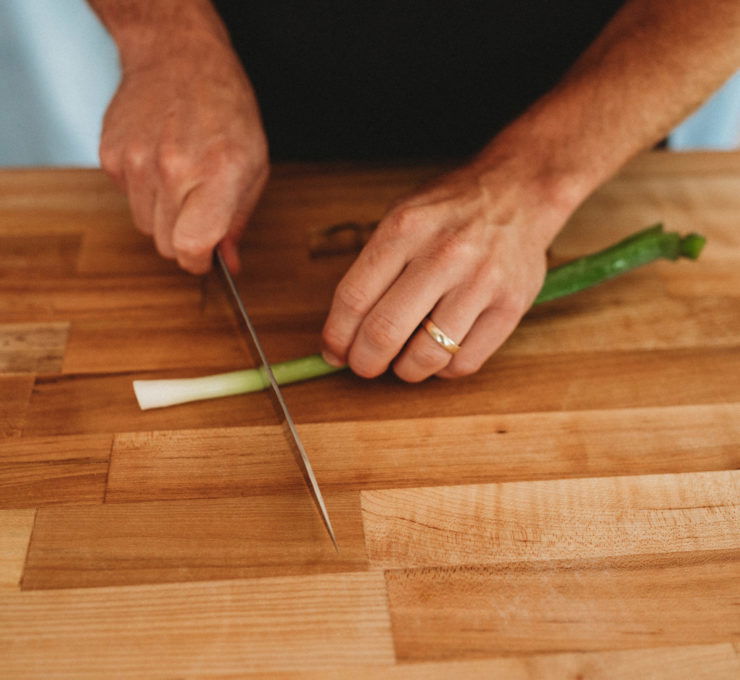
0, 153, 740, 680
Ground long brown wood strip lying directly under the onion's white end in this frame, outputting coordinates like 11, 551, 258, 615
18, 347, 740, 436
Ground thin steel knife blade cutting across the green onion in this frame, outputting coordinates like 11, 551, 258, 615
214, 248, 339, 552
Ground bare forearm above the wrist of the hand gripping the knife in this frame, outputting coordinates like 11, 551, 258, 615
88, 0, 230, 72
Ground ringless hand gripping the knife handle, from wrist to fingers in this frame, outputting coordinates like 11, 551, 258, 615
100, 35, 269, 274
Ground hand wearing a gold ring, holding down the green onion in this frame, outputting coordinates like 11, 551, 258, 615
323, 158, 568, 382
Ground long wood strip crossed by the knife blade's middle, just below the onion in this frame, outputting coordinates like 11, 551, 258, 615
107, 404, 740, 502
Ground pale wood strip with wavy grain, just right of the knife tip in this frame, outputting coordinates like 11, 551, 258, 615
362, 471, 740, 569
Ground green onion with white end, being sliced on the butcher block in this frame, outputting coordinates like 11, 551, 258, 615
134, 224, 706, 409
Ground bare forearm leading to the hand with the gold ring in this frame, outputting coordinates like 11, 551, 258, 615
478, 0, 740, 220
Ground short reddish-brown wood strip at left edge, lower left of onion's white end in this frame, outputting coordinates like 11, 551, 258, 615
0, 435, 112, 508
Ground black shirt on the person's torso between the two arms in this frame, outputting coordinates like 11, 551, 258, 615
210, 0, 623, 160
